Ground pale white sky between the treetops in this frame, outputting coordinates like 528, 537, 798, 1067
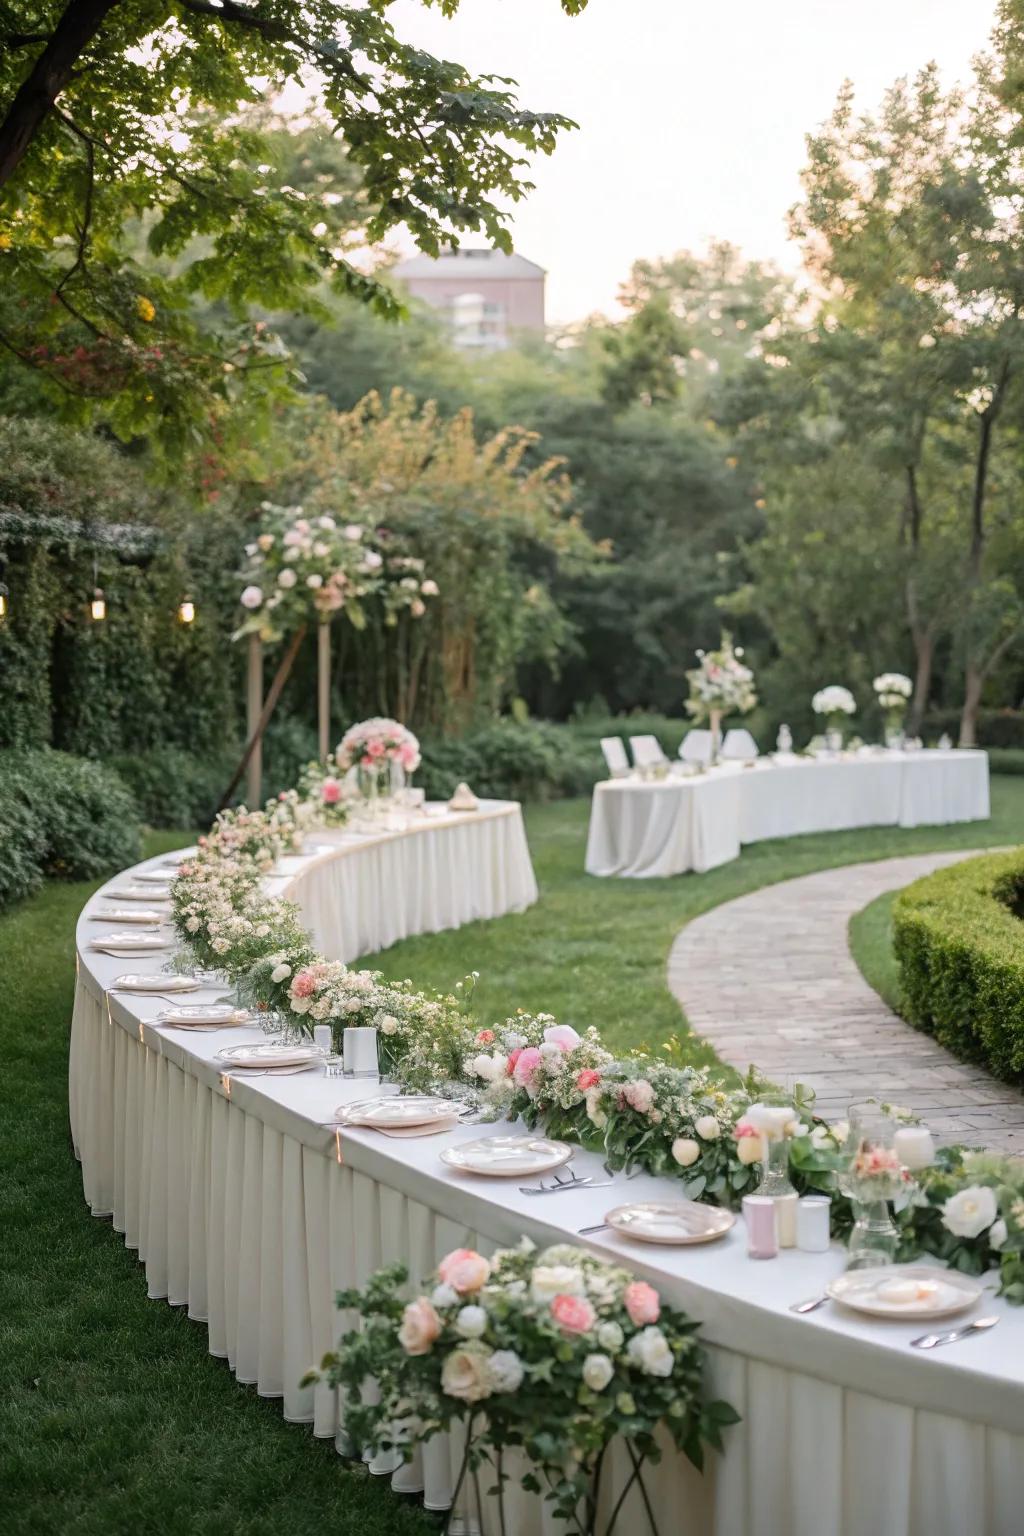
388, 0, 995, 324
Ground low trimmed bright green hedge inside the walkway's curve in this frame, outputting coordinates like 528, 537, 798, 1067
892, 848, 1024, 1081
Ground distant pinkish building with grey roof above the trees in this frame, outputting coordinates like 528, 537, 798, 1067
395, 246, 543, 352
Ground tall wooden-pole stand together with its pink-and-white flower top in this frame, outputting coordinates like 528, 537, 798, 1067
224, 502, 438, 805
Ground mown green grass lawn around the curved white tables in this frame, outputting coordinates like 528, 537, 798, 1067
0, 779, 1024, 1536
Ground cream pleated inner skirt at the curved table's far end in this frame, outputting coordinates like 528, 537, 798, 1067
269, 800, 537, 962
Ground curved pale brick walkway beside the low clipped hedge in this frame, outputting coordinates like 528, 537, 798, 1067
668, 852, 1024, 1152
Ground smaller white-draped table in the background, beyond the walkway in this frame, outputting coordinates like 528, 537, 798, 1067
586, 751, 989, 879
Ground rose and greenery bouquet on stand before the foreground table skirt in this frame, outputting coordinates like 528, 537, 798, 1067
306, 1240, 738, 1536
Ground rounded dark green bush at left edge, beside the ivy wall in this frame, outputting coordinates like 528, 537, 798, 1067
0, 748, 140, 906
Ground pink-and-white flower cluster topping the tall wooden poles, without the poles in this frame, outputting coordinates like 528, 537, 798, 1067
235, 502, 438, 641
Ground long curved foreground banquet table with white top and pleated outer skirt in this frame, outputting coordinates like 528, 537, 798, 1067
71, 804, 1024, 1536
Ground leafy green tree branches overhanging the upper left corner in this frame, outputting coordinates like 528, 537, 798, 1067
0, 0, 586, 445
